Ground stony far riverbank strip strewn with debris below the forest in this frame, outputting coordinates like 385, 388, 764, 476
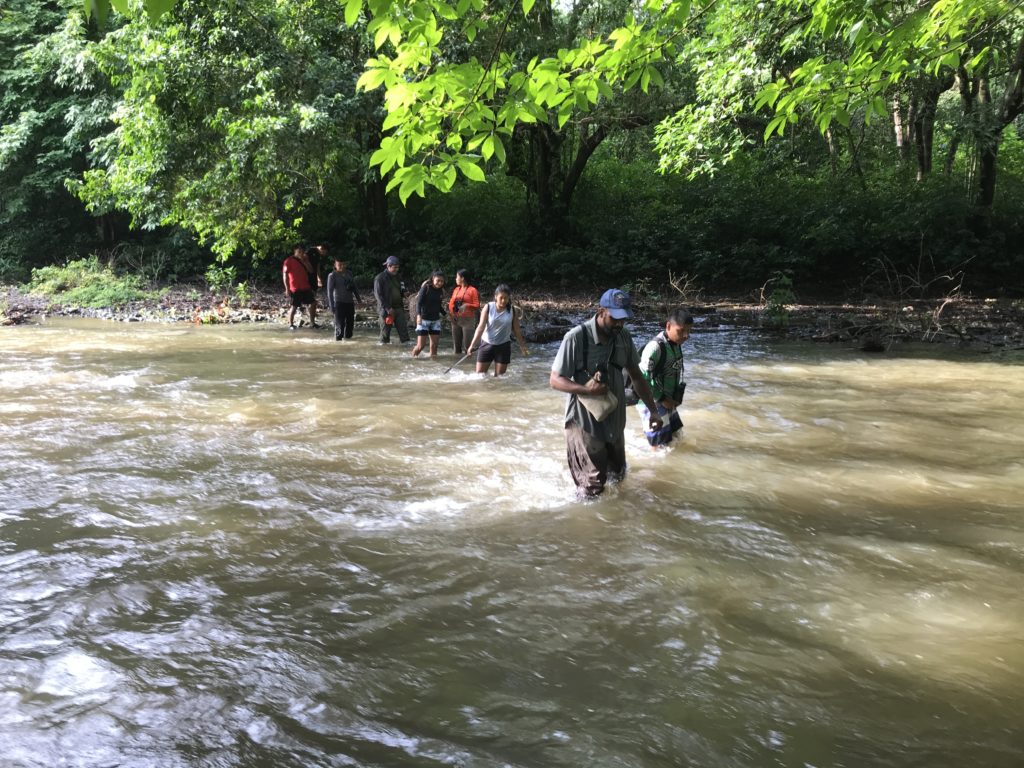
0, 286, 1024, 351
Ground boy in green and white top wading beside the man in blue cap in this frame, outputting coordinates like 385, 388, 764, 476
634, 309, 693, 447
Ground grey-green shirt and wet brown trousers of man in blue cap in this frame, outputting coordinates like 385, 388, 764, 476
551, 316, 639, 498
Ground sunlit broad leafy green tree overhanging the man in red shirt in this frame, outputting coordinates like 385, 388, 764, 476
79, 0, 382, 257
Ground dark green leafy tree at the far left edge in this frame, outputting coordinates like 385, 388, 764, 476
0, 0, 113, 276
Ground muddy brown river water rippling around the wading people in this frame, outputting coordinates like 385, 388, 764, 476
0, 319, 1024, 768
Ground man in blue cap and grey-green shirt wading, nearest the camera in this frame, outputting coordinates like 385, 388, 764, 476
550, 288, 662, 499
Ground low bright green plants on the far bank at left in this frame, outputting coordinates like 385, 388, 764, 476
25, 256, 158, 309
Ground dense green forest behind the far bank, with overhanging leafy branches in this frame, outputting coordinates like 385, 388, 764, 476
0, 0, 1024, 296
